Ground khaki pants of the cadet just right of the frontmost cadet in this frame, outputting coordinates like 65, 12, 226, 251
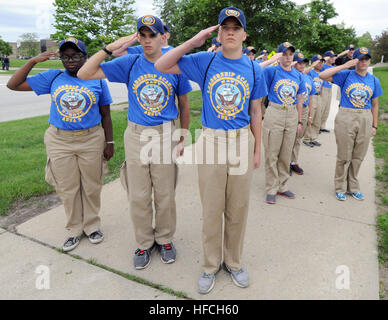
263, 102, 298, 195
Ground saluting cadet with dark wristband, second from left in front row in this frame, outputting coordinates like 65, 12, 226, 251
78, 15, 192, 269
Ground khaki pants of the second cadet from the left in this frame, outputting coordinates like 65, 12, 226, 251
121, 120, 177, 250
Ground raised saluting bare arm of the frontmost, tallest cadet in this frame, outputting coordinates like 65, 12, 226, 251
155, 25, 220, 74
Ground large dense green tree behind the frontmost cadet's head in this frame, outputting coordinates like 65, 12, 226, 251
154, 0, 356, 55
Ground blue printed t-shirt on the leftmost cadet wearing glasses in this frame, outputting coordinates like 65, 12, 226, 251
27, 69, 112, 130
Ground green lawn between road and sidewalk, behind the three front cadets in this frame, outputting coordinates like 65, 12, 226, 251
0, 92, 202, 215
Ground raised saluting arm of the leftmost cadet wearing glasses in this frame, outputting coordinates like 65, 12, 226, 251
7, 50, 59, 91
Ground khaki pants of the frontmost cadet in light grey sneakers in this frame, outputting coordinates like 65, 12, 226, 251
196, 127, 255, 273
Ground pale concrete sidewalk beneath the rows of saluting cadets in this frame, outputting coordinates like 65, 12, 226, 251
0, 85, 379, 300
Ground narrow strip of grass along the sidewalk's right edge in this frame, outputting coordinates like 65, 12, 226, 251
373, 68, 388, 263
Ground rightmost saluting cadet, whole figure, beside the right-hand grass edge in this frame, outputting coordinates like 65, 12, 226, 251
320, 47, 383, 201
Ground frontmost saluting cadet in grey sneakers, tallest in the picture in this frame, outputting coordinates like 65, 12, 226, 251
155, 7, 267, 294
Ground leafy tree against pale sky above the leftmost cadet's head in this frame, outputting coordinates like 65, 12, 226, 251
51, 0, 136, 55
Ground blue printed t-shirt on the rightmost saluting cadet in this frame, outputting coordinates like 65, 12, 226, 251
333, 70, 383, 109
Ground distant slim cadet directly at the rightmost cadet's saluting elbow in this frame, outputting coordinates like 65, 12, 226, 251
303, 54, 325, 148
